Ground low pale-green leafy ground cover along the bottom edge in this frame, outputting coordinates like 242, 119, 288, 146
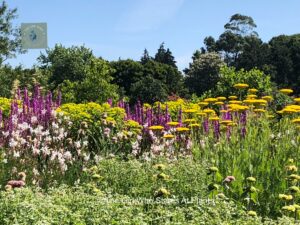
0, 187, 274, 225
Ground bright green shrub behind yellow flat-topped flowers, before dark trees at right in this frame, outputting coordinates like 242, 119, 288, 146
211, 66, 273, 96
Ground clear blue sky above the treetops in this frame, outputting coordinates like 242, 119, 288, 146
6, 0, 300, 69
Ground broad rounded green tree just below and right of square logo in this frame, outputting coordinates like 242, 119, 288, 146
38, 45, 117, 103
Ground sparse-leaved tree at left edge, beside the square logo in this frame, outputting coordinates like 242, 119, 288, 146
0, 1, 25, 66
